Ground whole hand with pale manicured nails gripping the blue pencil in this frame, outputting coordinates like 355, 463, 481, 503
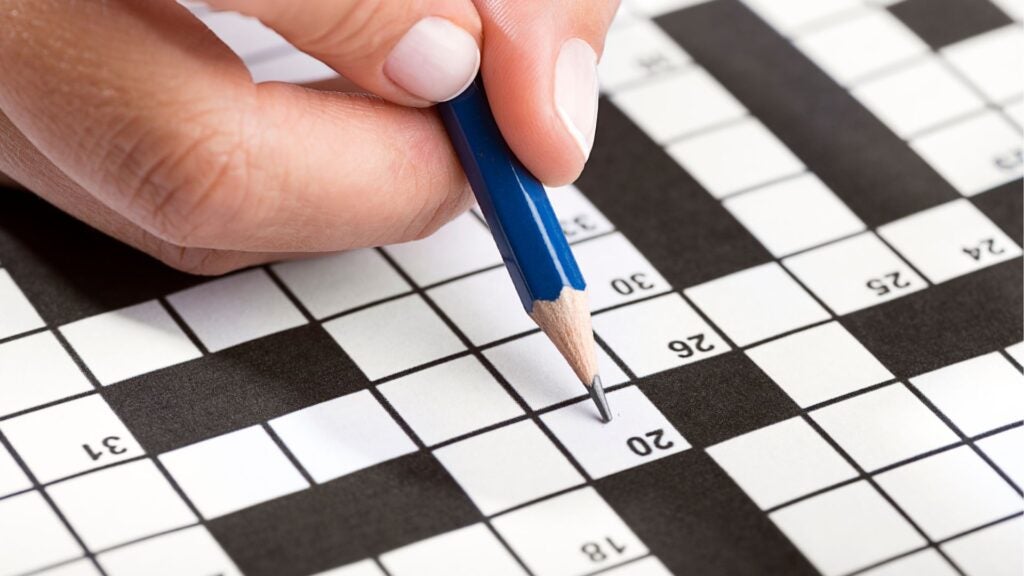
0, 0, 617, 274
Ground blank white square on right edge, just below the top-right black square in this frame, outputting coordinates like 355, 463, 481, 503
942, 23, 1024, 102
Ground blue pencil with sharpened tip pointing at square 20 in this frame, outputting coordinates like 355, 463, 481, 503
438, 77, 611, 422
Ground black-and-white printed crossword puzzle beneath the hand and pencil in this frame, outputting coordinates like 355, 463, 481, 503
0, 0, 1024, 576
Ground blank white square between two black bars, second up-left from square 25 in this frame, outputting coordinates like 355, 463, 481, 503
666, 118, 804, 198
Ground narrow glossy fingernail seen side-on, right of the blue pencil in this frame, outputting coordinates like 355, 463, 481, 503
555, 38, 597, 158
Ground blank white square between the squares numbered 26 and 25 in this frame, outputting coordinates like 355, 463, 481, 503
684, 262, 829, 346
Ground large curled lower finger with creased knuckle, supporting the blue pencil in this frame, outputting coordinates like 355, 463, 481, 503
0, 0, 470, 252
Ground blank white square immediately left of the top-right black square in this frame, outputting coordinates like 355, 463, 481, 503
796, 9, 929, 86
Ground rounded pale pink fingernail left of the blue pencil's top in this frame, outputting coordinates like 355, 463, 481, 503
384, 16, 480, 102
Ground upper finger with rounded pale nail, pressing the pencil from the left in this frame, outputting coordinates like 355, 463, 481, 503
207, 0, 481, 107
